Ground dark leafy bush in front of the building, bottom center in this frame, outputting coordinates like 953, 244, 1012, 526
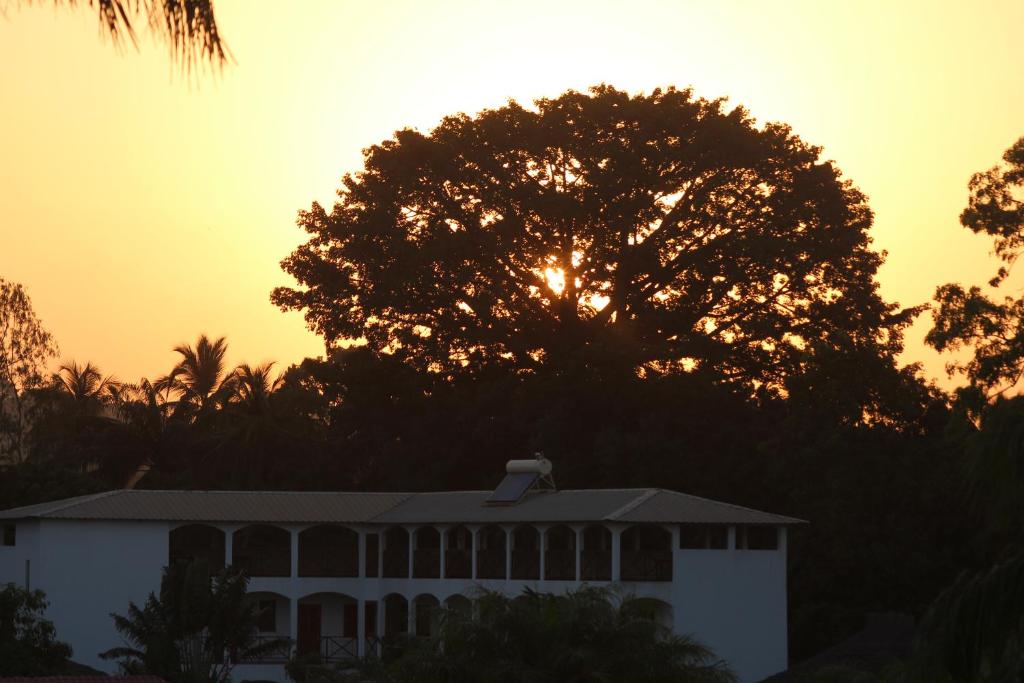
344, 588, 735, 683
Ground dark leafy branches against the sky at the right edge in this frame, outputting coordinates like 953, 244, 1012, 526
927, 137, 1024, 395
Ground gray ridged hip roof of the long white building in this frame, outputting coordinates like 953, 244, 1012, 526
0, 488, 803, 524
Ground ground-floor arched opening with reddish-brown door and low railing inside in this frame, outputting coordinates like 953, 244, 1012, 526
296, 593, 359, 661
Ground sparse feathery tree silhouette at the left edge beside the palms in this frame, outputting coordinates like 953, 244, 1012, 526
0, 278, 57, 462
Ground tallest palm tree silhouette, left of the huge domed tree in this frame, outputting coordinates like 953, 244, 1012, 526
154, 335, 236, 419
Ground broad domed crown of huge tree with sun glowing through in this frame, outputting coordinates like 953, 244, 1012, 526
271, 86, 912, 387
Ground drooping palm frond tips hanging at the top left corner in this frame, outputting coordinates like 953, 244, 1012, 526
24, 0, 229, 69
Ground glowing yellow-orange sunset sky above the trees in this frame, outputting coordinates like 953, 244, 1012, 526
0, 0, 1024, 386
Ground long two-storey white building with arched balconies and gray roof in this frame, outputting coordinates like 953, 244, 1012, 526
0, 461, 800, 683
